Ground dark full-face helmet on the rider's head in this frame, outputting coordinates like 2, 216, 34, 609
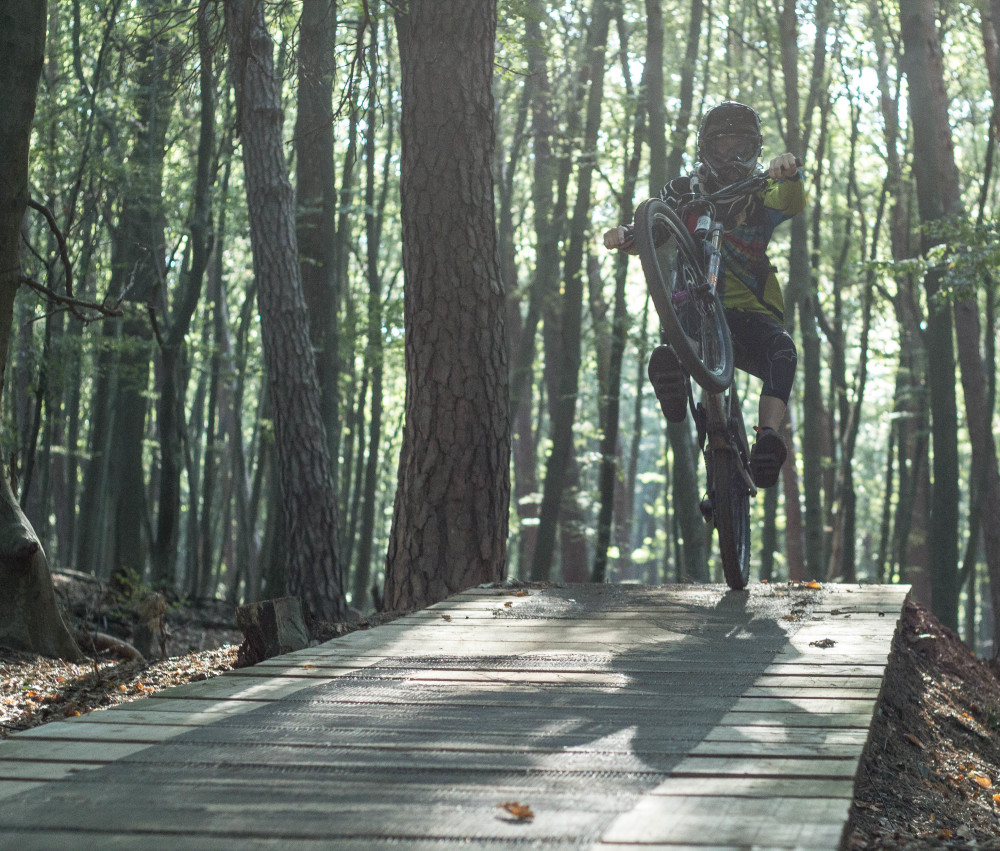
698, 101, 764, 186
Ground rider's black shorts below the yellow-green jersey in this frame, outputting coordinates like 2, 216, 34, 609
726, 310, 798, 404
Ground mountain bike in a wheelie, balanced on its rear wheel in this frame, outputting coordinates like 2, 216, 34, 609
634, 174, 770, 590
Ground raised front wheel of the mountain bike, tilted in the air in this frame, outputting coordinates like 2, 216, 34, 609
635, 198, 733, 393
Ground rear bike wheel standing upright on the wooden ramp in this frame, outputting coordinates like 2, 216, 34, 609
708, 449, 750, 591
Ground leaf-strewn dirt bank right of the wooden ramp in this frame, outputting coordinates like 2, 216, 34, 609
847, 603, 1000, 849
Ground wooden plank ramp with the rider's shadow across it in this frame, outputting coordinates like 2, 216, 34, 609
0, 585, 906, 851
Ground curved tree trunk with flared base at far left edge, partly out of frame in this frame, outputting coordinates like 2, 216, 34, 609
0, 0, 82, 661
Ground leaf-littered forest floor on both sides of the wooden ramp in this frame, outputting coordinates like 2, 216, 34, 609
0, 575, 1000, 851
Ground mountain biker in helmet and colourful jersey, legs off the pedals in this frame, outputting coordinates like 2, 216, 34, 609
604, 101, 805, 488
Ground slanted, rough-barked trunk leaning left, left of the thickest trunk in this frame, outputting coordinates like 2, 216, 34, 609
226, 0, 344, 620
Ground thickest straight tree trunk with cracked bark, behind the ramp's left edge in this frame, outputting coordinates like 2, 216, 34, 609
384, 0, 510, 609
